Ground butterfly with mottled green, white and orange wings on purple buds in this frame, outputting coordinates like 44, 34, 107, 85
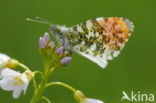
26, 17, 134, 68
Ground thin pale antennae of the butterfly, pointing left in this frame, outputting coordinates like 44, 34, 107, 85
26, 17, 53, 25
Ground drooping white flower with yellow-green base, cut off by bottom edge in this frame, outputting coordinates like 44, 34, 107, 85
74, 90, 104, 103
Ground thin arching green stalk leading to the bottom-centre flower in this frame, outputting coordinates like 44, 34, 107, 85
46, 82, 77, 93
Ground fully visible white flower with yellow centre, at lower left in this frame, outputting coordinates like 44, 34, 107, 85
0, 68, 34, 98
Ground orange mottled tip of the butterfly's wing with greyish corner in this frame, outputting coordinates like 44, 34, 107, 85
97, 17, 134, 50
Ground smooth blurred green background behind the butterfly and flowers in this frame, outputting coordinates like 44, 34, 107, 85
0, 0, 156, 103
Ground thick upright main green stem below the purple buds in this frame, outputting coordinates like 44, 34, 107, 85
30, 68, 54, 103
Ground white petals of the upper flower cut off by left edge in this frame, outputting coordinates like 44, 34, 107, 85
0, 53, 11, 70
